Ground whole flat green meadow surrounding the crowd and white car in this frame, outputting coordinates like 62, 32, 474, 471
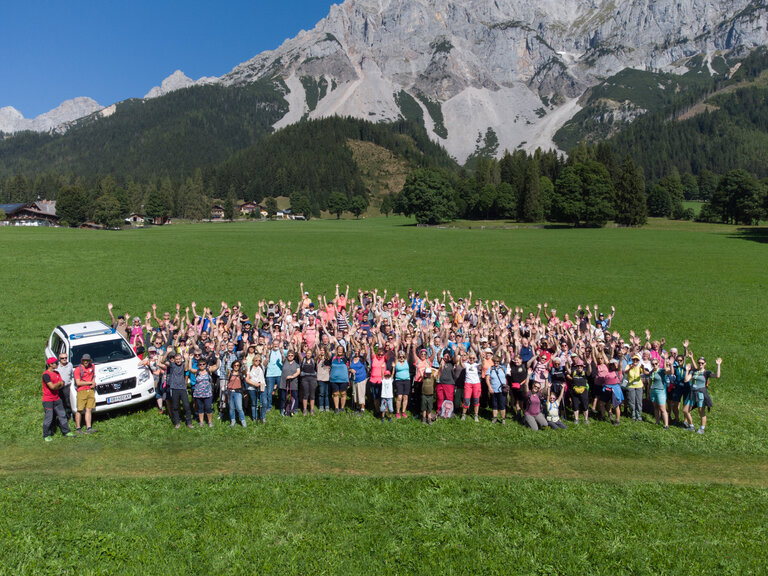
0, 218, 768, 574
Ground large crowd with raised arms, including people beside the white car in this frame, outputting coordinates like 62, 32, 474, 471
43, 283, 722, 439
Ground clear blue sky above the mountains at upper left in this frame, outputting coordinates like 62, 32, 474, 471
0, 0, 342, 118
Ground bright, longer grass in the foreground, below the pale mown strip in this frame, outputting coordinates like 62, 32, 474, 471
0, 476, 768, 576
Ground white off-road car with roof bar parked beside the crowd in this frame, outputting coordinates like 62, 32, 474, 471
45, 322, 155, 412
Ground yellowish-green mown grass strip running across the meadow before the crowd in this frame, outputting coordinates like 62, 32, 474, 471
0, 442, 768, 487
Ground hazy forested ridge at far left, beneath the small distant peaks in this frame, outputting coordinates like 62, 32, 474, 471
0, 81, 288, 181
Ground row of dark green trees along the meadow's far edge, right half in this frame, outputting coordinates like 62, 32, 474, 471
390, 143, 768, 227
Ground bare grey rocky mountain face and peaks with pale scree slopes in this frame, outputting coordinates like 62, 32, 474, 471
0, 0, 768, 162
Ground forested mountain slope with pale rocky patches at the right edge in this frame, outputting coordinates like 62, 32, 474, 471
556, 48, 768, 182
